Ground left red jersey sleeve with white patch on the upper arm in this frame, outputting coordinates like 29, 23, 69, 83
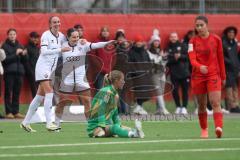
188, 38, 202, 70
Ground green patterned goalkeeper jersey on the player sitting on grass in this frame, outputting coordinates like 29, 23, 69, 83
87, 85, 120, 137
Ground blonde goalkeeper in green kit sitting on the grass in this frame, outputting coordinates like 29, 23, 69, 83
87, 70, 144, 138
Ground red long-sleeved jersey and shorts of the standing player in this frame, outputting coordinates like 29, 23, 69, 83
188, 33, 226, 94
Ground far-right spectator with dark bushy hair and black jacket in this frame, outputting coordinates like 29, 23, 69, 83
222, 26, 240, 113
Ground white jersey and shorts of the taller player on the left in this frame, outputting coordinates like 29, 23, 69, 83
35, 30, 65, 81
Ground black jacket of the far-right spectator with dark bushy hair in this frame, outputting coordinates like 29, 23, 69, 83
222, 36, 240, 76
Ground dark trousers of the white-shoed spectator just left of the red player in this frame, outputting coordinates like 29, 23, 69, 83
171, 78, 189, 107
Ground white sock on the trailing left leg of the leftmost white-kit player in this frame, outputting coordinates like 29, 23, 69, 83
22, 95, 44, 125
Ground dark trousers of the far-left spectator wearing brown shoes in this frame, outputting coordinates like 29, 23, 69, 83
4, 74, 23, 114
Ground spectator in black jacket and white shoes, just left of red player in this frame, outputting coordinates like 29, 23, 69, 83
166, 32, 190, 114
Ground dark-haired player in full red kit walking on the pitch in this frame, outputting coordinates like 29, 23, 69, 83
188, 16, 226, 138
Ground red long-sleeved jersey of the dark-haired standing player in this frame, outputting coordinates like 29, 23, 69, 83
188, 34, 226, 80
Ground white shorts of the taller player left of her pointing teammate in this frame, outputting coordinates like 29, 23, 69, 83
35, 56, 58, 82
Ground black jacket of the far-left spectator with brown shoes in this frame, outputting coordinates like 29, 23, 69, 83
2, 39, 26, 75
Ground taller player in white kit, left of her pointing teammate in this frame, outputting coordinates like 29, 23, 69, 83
20, 16, 71, 132
